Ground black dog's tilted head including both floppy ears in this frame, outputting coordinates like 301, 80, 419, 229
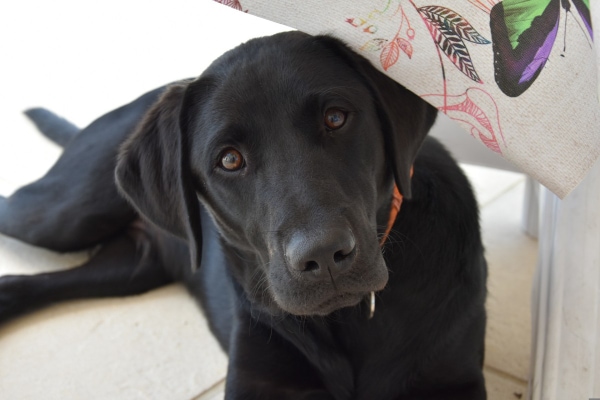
116, 32, 436, 315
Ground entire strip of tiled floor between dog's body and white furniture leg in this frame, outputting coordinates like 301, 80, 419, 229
465, 166, 537, 400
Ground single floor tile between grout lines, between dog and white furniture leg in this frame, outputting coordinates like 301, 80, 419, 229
481, 183, 537, 381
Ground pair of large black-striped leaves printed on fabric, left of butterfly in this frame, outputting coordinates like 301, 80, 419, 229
417, 6, 490, 83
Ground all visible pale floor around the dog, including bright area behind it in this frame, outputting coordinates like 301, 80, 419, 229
0, 0, 537, 400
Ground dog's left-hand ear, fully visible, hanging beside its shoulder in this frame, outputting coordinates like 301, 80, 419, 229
115, 81, 202, 269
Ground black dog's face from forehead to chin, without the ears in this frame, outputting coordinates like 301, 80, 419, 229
183, 34, 392, 315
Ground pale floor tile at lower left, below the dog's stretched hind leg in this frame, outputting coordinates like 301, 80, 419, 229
0, 285, 226, 400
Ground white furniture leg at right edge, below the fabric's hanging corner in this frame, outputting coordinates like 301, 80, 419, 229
529, 163, 600, 400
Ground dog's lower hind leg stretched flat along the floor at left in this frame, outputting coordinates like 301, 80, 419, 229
0, 223, 176, 322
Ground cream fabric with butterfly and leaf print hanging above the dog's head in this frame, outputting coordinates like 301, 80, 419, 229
219, 0, 600, 197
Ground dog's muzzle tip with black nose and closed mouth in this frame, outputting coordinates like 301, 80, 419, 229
245, 219, 389, 316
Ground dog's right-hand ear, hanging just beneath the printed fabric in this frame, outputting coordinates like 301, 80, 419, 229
317, 36, 437, 198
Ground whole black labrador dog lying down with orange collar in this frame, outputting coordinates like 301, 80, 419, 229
0, 32, 487, 400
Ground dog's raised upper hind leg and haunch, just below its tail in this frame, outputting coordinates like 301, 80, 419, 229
0, 89, 162, 251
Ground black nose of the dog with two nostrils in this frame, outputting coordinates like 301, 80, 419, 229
286, 229, 356, 280
